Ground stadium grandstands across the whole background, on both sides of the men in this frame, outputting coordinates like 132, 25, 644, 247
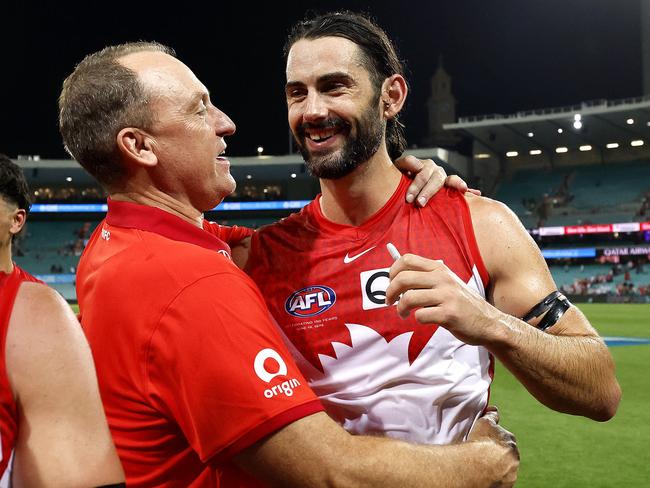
10, 97, 650, 302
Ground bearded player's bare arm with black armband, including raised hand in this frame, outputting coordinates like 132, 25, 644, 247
386, 196, 621, 420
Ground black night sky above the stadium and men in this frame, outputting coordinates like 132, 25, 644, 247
0, 0, 642, 158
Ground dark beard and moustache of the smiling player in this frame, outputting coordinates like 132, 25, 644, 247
296, 103, 385, 180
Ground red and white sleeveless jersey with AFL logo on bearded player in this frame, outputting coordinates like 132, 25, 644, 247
246, 177, 492, 444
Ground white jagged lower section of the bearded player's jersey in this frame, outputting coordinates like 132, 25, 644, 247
292, 267, 490, 444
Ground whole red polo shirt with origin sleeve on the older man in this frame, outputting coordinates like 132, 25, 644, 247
77, 200, 322, 487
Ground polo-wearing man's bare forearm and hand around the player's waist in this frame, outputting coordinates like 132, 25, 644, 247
236, 413, 519, 488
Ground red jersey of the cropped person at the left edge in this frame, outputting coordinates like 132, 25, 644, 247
0, 264, 40, 478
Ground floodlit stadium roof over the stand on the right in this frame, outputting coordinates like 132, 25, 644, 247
444, 96, 650, 158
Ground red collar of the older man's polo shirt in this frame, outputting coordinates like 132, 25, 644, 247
106, 198, 230, 255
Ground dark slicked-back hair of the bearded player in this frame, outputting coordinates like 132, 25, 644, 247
284, 10, 406, 160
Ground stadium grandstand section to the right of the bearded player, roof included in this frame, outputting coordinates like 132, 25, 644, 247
444, 96, 650, 302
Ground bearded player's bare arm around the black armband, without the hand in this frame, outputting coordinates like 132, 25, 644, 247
467, 197, 621, 420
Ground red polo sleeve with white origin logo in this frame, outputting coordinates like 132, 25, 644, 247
147, 270, 323, 461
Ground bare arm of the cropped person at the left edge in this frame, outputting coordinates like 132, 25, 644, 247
6, 283, 124, 487
